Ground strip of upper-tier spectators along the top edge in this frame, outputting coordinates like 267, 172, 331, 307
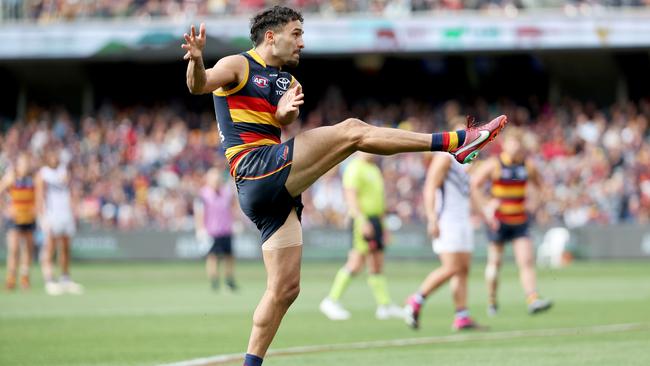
0, 0, 650, 22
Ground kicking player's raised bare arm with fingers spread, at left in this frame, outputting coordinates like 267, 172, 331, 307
181, 23, 246, 94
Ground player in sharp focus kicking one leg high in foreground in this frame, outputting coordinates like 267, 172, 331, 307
181, 6, 507, 366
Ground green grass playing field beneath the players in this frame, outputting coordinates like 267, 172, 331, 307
0, 262, 650, 366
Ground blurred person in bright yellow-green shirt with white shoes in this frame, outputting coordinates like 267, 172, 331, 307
320, 153, 404, 320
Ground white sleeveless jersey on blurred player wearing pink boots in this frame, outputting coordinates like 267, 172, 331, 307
436, 154, 470, 225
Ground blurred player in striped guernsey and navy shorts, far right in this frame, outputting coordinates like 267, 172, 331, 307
472, 128, 552, 316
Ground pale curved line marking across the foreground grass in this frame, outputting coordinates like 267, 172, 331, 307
161, 323, 650, 366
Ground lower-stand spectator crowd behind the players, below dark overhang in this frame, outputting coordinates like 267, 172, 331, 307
0, 94, 650, 230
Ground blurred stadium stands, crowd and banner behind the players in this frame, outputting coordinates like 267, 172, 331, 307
0, 0, 650, 264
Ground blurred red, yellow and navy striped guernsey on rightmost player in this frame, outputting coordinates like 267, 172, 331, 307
492, 154, 528, 225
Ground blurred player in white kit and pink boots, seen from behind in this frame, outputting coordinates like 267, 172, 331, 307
404, 118, 488, 330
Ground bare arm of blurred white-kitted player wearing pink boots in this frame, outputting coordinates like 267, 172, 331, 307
424, 154, 451, 238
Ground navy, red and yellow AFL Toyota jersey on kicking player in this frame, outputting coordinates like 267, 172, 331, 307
212, 49, 295, 176
